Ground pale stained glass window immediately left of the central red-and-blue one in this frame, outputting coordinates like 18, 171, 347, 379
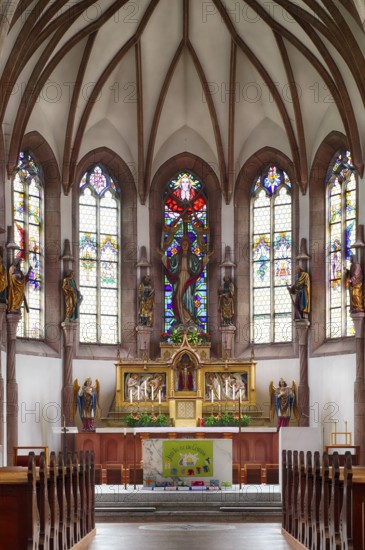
79, 165, 120, 344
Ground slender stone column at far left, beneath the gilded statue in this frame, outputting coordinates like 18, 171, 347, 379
6, 313, 21, 466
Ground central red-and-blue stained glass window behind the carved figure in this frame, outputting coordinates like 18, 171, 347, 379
161, 172, 209, 332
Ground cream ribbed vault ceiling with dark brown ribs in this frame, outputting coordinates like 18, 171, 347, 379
0, 0, 365, 202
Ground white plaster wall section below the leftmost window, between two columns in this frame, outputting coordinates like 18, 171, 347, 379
16, 355, 62, 460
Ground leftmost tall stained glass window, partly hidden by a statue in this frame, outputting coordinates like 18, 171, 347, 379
13, 151, 44, 339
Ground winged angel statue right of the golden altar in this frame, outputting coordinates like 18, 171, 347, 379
269, 378, 299, 431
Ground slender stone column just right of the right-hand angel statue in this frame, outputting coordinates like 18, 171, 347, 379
294, 319, 310, 427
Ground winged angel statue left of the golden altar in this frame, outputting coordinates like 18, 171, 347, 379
72, 378, 100, 432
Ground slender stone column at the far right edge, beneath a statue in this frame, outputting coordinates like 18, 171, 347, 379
351, 312, 365, 465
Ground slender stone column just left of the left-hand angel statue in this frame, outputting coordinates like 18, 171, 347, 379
61, 321, 78, 426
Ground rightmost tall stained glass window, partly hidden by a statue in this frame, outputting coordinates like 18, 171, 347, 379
327, 151, 357, 338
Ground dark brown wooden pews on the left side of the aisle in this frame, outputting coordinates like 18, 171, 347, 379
0, 452, 95, 550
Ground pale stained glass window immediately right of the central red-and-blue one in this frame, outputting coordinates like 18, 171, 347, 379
251, 165, 292, 344
